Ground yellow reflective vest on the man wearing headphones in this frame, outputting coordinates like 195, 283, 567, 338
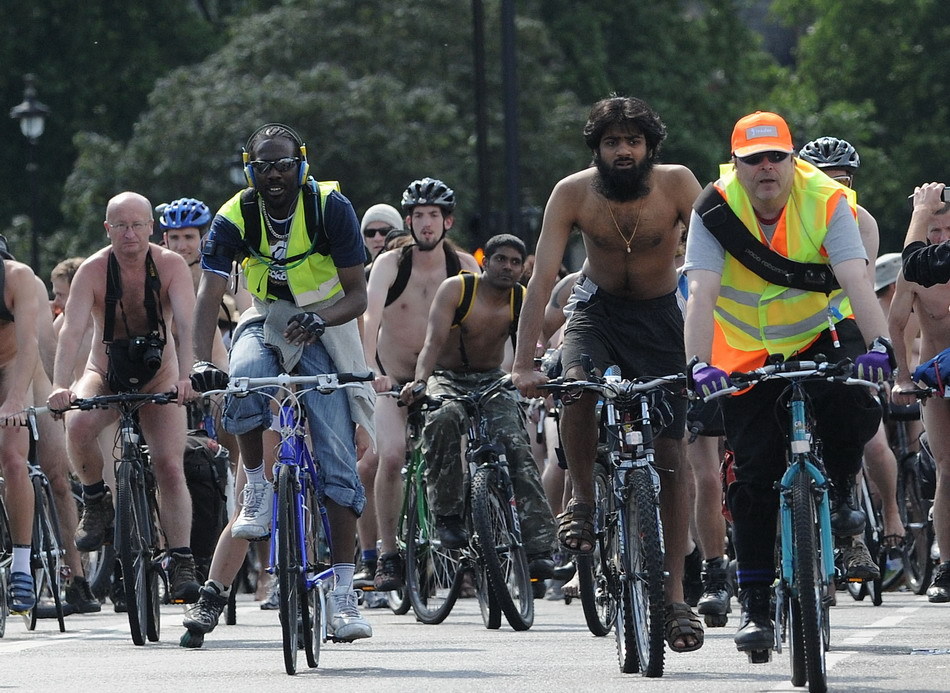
218, 182, 342, 306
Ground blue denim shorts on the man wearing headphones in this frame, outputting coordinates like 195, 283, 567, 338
221, 322, 366, 515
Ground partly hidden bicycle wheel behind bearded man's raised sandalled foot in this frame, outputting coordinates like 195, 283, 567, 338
574, 465, 617, 637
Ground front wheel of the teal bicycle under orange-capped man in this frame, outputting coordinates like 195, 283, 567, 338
792, 472, 828, 693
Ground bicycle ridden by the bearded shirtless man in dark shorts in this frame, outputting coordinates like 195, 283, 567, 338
542, 366, 686, 678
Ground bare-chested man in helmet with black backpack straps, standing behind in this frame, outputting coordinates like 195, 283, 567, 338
363, 178, 478, 591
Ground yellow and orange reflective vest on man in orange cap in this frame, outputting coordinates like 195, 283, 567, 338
712, 159, 857, 373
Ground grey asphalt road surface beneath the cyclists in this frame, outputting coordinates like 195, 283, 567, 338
0, 580, 950, 693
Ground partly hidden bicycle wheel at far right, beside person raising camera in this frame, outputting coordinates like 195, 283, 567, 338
897, 455, 934, 594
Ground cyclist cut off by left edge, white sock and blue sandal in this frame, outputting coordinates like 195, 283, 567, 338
0, 236, 45, 612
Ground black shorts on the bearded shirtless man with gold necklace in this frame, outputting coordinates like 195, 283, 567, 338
561, 282, 686, 440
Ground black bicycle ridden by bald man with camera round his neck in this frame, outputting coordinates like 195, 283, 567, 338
50, 392, 178, 646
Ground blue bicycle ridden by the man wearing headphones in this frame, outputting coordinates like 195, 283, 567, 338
179, 372, 374, 675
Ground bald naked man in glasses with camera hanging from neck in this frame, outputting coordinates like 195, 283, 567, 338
49, 192, 198, 602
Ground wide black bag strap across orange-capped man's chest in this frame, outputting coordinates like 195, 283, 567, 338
693, 183, 841, 294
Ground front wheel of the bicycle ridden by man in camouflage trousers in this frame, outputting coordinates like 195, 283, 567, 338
472, 465, 534, 630
